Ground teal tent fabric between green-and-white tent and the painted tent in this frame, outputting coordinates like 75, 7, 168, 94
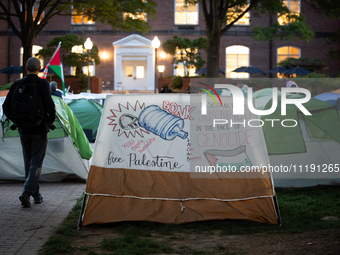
68, 99, 103, 138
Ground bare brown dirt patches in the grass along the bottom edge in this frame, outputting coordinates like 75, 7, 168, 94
71, 226, 340, 255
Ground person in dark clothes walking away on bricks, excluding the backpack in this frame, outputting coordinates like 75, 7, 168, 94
3, 57, 56, 207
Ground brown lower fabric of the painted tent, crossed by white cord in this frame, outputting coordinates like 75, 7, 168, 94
83, 166, 277, 226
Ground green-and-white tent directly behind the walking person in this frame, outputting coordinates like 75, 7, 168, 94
0, 96, 92, 182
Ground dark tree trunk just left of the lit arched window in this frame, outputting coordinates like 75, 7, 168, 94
207, 28, 221, 78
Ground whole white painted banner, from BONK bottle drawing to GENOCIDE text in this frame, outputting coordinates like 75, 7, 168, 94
92, 94, 268, 178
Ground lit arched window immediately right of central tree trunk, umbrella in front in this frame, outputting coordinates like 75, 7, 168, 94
226, 45, 249, 78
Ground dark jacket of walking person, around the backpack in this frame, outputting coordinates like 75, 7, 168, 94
2, 74, 56, 135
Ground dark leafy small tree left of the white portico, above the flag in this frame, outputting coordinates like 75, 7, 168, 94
35, 34, 100, 76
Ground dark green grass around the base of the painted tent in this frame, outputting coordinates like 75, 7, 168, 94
40, 186, 340, 255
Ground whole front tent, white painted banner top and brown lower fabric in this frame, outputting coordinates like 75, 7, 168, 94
81, 94, 279, 226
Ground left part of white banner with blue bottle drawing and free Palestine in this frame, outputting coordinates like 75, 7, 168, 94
93, 95, 196, 172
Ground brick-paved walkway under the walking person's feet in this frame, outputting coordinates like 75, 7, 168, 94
0, 182, 85, 255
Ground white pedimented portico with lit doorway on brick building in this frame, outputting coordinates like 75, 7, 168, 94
112, 34, 155, 90
